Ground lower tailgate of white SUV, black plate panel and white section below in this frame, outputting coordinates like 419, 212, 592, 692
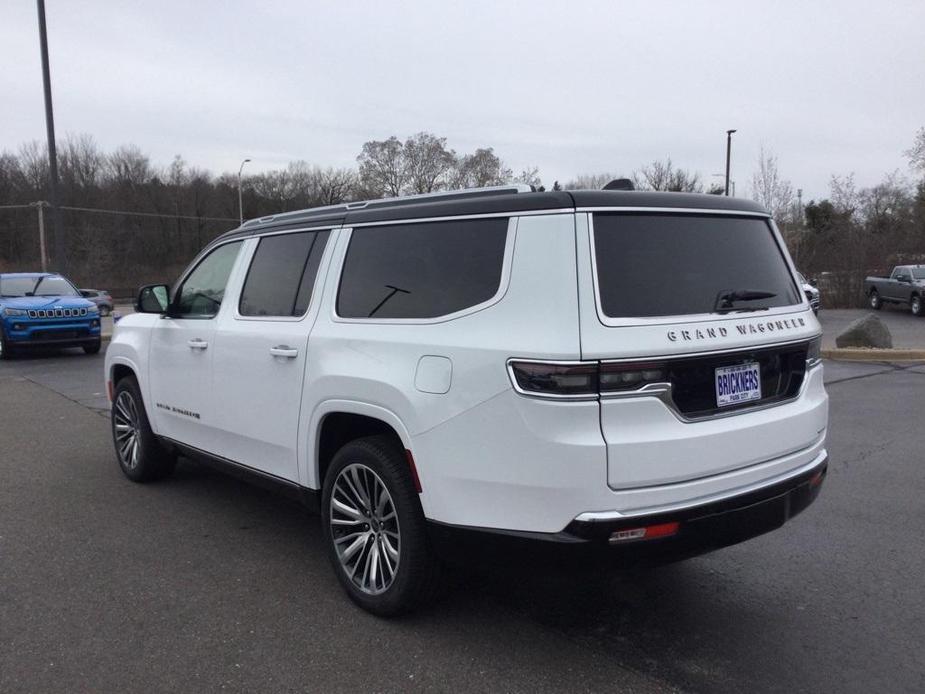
601, 343, 826, 489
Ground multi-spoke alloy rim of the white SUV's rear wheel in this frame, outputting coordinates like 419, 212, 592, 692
328, 463, 401, 595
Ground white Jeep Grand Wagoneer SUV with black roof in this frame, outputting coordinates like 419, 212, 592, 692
105, 187, 828, 614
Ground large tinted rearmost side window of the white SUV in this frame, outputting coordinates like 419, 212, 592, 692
337, 219, 508, 318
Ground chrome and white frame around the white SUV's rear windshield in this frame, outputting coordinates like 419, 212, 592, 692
588, 207, 812, 328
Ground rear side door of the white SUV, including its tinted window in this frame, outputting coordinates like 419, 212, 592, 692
212, 229, 331, 481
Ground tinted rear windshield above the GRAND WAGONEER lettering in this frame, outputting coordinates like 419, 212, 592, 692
594, 213, 801, 318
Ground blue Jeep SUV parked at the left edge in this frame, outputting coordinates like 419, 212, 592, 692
0, 272, 100, 359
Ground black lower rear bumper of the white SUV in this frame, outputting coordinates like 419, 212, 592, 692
428, 458, 828, 568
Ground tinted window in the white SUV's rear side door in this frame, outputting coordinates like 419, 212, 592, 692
238, 231, 330, 317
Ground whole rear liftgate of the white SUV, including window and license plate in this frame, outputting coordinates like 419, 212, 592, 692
577, 210, 825, 489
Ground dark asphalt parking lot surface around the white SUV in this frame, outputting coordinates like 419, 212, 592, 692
0, 354, 925, 693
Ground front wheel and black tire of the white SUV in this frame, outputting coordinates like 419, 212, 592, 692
110, 376, 177, 482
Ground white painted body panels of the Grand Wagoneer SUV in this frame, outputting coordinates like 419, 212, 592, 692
106, 204, 827, 532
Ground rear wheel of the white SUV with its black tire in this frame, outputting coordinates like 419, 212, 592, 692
321, 436, 441, 617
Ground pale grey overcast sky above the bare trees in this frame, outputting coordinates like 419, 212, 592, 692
0, 0, 925, 199
